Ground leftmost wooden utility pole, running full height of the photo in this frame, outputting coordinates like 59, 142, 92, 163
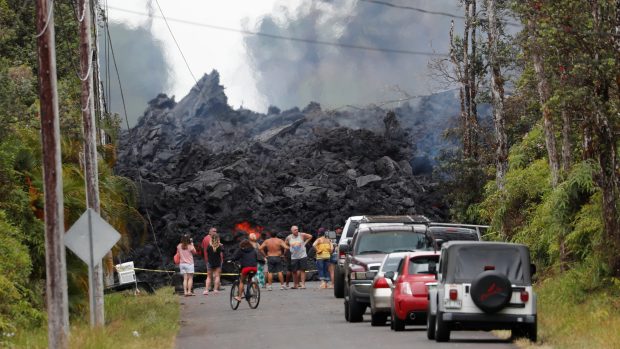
36, 0, 69, 349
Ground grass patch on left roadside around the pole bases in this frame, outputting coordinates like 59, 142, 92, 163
14, 287, 179, 349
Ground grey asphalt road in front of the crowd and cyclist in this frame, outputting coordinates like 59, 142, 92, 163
176, 282, 515, 349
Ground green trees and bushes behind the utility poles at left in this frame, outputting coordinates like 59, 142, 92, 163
0, 0, 148, 348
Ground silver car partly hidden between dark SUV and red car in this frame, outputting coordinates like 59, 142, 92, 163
370, 252, 409, 326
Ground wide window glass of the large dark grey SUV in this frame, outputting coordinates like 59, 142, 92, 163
355, 230, 429, 254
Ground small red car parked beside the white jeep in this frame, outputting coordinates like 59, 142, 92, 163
385, 251, 439, 331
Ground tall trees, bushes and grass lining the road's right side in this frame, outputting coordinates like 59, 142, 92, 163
435, 0, 620, 348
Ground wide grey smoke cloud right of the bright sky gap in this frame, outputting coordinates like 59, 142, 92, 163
245, 0, 462, 108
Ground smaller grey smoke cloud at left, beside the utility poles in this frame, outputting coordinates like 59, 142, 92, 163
99, 21, 172, 127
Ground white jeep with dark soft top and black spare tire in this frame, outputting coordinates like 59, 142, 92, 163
427, 241, 537, 342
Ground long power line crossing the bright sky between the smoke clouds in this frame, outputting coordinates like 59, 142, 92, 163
109, 6, 449, 57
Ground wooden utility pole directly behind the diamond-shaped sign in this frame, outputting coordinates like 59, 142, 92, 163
78, 0, 104, 327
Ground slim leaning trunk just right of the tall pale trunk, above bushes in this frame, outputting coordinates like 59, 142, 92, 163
528, 19, 560, 188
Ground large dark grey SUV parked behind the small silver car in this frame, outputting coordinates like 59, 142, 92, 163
339, 224, 430, 322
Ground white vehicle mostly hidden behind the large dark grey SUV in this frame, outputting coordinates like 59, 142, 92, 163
334, 215, 430, 298
